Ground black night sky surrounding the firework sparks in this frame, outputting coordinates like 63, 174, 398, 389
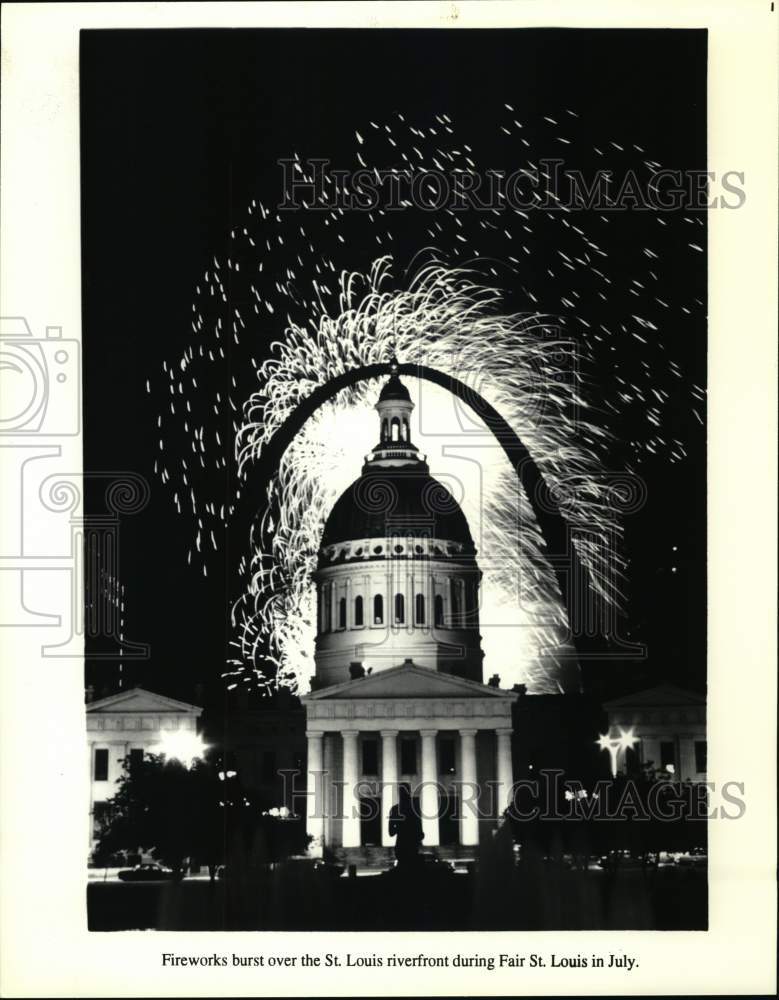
81, 29, 706, 698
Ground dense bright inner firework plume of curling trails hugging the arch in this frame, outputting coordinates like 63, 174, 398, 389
236, 261, 619, 692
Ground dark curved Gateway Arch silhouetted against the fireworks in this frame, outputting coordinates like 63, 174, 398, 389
247, 359, 602, 690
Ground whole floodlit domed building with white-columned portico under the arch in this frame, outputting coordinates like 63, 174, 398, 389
303, 375, 516, 863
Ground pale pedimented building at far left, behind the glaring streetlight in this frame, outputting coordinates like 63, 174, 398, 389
86, 688, 202, 850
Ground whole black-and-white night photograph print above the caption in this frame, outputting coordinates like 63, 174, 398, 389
78, 28, 720, 932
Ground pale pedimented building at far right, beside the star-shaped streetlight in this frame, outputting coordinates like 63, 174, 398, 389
603, 684, 706, 781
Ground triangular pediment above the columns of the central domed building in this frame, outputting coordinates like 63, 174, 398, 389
301, 663, 517, 702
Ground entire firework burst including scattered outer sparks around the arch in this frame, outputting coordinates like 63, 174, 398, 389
151, 104, 704, 682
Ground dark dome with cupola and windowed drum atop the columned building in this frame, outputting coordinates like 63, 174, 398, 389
314, 375, 482, 686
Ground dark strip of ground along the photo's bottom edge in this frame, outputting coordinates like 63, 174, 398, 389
87, 865, 708, 931
